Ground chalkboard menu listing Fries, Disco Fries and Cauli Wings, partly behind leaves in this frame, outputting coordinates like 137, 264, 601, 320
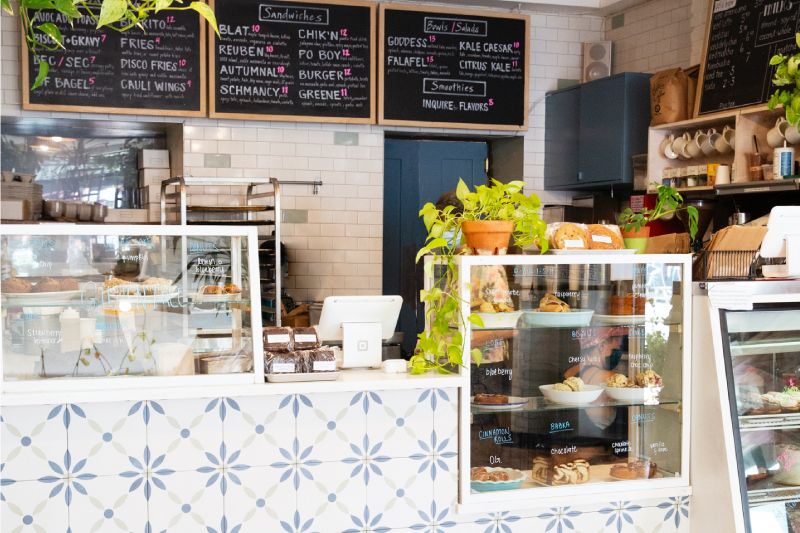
22, 11, 206, 117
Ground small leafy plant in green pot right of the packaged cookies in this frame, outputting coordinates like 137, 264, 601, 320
617, 185, 698, 253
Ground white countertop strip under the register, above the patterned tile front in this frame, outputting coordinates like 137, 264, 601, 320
0, 369, 465, 405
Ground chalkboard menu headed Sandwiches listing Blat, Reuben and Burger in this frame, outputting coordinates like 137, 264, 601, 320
210, 0, 375, 124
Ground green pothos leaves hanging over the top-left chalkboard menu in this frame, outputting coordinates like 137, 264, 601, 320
0, 0, 219, 90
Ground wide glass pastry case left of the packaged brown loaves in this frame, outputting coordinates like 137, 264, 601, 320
0, 224, 263, 391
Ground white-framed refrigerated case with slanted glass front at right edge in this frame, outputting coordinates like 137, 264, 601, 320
708, 281, 800, 533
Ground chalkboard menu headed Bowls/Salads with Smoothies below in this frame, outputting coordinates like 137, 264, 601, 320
378, 4, 529, 130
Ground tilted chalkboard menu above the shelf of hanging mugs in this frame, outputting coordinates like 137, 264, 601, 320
695, 0, 800, 115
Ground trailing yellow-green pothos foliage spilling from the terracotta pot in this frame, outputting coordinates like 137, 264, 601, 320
409, 179, 547, 374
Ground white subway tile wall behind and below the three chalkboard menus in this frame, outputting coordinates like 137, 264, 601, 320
0, 8, 600, 301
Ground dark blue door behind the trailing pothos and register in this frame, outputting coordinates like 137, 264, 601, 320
383, 139, 488, 354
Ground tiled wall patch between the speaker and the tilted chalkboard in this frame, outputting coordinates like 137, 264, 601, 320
605, 0, 709, 73
